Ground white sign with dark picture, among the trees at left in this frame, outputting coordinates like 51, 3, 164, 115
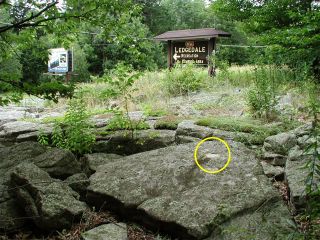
48, 48, 69, 73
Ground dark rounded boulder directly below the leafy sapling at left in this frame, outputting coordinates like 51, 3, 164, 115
32, 148, 81, 179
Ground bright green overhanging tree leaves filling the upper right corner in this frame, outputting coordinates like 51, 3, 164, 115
213, 0, 320, 78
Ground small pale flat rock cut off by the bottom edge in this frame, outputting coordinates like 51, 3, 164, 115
82, 223, 128, 240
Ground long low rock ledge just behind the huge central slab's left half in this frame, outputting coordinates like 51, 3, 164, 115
93, 129, 175, 155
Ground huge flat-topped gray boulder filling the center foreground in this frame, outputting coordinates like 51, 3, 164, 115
87, 141, 289, 239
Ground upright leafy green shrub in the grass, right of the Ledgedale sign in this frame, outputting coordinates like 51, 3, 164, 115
247, 67, 278, 120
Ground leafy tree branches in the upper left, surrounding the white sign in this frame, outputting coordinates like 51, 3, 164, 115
0, 0, 138, 105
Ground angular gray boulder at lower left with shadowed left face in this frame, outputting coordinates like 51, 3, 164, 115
11, 163, 87, 230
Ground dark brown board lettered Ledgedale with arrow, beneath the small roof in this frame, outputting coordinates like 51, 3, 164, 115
172, 41, 209, 65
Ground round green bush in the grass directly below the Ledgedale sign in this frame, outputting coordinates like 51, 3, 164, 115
164, 64, 208, 96
